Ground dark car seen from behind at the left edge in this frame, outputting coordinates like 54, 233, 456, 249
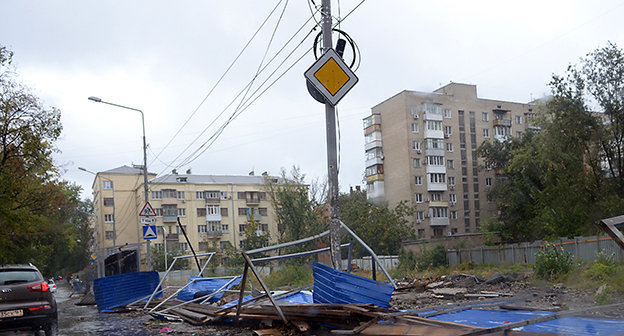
0, 264, 58, 335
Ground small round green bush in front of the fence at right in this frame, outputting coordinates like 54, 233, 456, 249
533, 245, 574, 281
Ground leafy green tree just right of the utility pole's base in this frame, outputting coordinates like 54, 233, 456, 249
338, 191, 414, 257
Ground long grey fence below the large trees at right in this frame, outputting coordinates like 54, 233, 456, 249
446, 236, 624, 266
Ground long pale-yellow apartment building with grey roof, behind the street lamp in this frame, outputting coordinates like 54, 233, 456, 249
93, 166, 278, 268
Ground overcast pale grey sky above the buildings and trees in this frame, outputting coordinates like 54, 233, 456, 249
0, 0, 624, 197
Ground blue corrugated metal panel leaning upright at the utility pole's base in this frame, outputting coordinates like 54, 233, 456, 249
312, 262, 394, 308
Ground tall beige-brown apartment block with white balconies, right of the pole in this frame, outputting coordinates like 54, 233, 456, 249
364, 83, 537, 239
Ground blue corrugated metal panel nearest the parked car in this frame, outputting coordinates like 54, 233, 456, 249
93, 271, 162, 311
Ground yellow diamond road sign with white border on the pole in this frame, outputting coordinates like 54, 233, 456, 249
304, 49, 358, 105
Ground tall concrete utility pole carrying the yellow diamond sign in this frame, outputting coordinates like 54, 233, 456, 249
321, 0, 342, 270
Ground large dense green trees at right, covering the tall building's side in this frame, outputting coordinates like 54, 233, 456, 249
479, 43, 624, 241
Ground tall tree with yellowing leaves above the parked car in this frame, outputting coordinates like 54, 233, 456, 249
0, 46, 90, 273
